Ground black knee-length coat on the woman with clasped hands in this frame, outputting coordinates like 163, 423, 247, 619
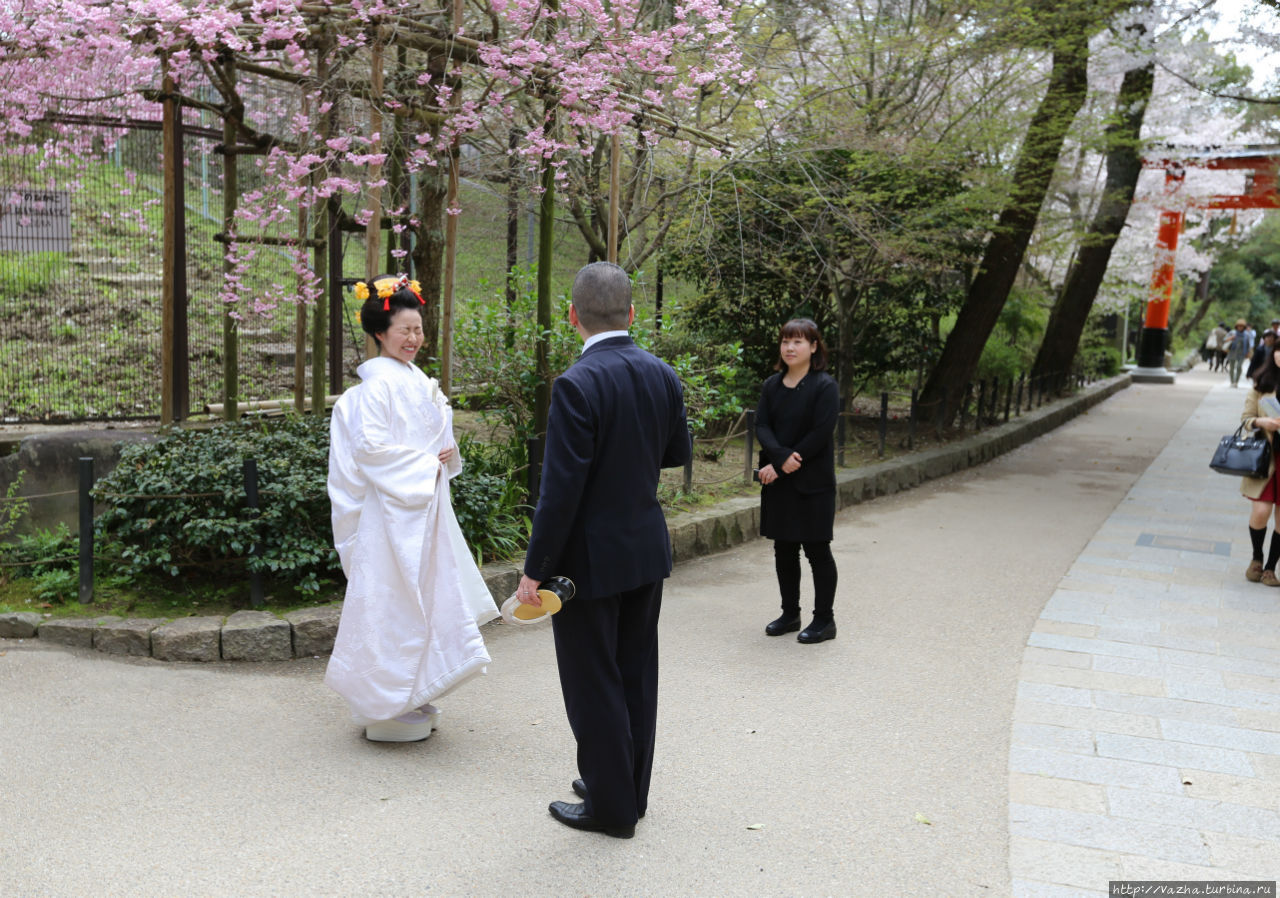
755, 371, 840, 542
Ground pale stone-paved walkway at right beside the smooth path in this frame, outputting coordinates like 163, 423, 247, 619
1009, 382, 1280, 898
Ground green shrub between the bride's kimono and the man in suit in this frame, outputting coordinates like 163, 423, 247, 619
449, 434, 532, 563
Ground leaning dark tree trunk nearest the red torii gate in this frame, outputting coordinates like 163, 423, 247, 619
1032, 61, 1156, 375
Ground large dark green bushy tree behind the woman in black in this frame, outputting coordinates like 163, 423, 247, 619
666, 148, 980, 379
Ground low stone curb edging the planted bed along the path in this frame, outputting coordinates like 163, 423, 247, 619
0, 374, 1132, 661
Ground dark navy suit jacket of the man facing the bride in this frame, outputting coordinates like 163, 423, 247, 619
525, 336, 691, 599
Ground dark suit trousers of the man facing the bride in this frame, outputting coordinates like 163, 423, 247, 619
552, 581, 662, 826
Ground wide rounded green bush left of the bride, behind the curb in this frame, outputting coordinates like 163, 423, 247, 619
93, 416, 338, 592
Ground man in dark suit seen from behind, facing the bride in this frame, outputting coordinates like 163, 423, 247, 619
516, 262, 691, 838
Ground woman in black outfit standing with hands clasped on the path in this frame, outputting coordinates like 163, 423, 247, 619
755, 319, 840, 642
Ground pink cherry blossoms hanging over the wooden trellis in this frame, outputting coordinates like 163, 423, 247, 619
0, 0, 754, 313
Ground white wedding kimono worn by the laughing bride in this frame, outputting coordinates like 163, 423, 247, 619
325, 357, 498, 725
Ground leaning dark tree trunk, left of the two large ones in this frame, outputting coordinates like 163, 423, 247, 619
920, 31, 1089, 425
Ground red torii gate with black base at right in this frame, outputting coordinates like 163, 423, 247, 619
1133, 146, 1280, 384
